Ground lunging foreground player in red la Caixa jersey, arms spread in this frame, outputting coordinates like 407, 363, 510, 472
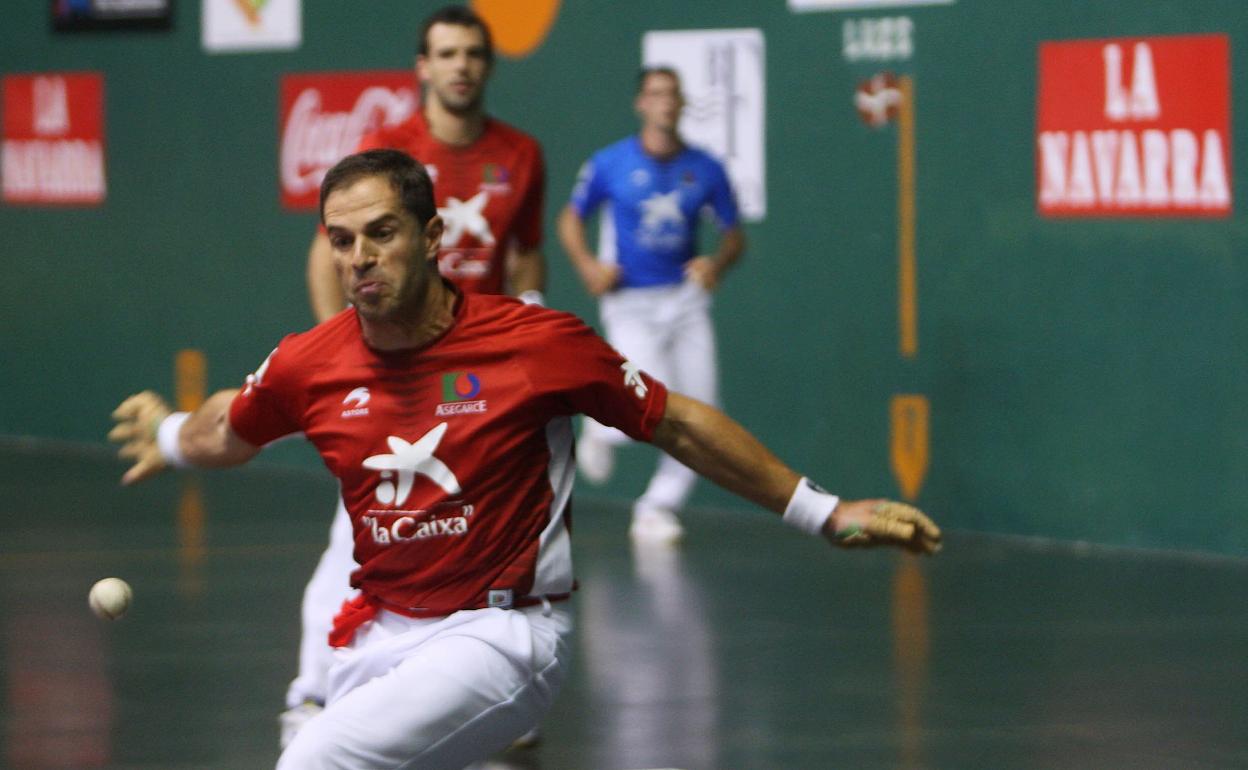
110, 150, 941, 770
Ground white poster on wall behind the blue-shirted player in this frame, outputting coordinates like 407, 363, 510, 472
641, 29, 768, 222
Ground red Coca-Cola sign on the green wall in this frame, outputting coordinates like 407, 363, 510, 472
278, 70, 417, 210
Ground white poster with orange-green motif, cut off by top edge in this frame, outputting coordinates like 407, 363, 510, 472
201, 0, 303, 54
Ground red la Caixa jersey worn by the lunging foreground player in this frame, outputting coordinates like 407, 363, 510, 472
230, 295, 666, 615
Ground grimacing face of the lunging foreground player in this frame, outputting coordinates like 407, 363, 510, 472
324, 176, 442, 322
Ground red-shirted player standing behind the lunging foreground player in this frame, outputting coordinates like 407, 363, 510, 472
294, 5, 545, 746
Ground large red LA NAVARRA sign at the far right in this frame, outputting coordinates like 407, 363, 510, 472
1036, 35, 1232, 217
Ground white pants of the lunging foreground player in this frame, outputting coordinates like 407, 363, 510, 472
277, 607, 572, 770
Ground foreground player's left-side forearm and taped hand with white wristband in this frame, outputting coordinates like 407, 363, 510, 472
109, 389, 260, 484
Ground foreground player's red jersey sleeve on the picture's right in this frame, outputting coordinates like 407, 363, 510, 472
525, 308, 668, 442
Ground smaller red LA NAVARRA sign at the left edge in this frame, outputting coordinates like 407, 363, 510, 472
0, 72, 105, 206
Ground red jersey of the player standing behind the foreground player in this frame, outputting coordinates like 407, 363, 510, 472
357, 110, 545, 295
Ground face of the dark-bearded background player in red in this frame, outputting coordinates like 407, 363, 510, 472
416, 24, 489, 114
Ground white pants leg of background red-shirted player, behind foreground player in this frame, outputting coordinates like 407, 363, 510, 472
286, 497, 356, 708
